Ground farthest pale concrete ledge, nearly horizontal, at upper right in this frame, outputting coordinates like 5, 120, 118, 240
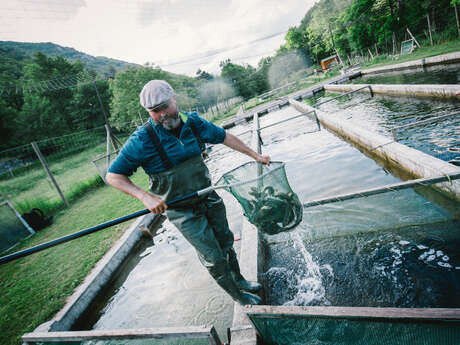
324, 84, 460, 99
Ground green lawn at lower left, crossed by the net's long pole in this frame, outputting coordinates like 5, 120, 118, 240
0, 172, 147, 345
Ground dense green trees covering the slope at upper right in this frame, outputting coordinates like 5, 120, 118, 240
280, 0, 460, 63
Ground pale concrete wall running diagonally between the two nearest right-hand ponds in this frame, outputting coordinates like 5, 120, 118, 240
290, 99, 460, 201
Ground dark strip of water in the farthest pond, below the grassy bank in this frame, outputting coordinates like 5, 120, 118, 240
353, 64, 460, 84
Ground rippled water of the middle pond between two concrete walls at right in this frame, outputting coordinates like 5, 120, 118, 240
310, 93, 460, 165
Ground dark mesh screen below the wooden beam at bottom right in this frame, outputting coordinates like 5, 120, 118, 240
249, 314, 460, 345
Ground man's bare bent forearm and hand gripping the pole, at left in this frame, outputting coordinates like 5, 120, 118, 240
106, 172, 168, 214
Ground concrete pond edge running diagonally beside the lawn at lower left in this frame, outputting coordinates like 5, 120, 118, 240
35, 214, 157, 332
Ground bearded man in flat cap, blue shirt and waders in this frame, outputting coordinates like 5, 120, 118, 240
106, 80, 270, 305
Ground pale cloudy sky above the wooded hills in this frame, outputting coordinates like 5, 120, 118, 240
0, 0, 317, 76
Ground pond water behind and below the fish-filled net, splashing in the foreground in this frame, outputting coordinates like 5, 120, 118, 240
261, 108, 460, 307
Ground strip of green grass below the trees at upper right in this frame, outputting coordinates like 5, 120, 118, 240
362, 39, 460, 68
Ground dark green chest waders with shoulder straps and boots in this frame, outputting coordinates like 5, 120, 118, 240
144, 122, 262, 305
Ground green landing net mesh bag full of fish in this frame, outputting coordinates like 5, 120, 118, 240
217, 161, 303, 235
